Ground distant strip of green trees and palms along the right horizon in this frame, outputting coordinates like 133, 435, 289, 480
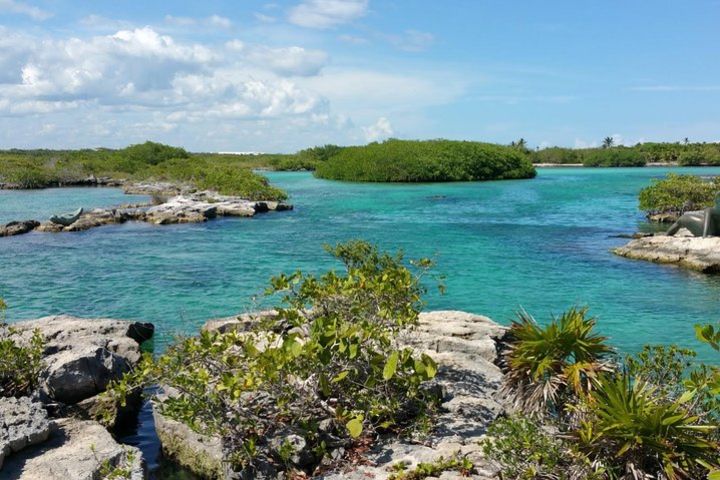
528, 143, 720, 167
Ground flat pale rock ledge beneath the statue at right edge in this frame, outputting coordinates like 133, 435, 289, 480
613, 235, 720, 273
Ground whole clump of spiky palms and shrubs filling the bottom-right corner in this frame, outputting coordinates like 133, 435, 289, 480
484, 309, 720, 480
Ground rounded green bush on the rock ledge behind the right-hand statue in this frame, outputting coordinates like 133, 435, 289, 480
639, 173, 720, 216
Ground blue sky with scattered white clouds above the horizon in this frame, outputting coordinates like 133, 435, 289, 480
0, 0, 720, 152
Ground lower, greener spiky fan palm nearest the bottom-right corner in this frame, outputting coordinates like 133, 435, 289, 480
576, 373, 720, 480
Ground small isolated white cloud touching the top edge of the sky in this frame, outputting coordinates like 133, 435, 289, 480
288, 0, 368, 28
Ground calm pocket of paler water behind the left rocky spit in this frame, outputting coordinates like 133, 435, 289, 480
0, 187, 148, 225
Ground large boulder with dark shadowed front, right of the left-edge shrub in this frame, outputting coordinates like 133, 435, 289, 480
14, 315, 153, 404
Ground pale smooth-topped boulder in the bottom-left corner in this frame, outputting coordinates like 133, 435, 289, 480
0, 418, 144, 480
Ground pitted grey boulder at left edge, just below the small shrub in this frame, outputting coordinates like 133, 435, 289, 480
0, 397, 53, 468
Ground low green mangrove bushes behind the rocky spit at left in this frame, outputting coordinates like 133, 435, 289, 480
0, 142, 286, 200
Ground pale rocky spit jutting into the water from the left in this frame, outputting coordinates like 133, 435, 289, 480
0, 182, 293, 237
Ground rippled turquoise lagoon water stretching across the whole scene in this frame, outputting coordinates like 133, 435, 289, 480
0, 168, 720, 358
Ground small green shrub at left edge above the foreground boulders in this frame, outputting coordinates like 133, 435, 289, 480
0, 298, 45, 397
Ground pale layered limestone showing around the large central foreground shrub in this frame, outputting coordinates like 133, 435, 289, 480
155, 311, 505, 480
